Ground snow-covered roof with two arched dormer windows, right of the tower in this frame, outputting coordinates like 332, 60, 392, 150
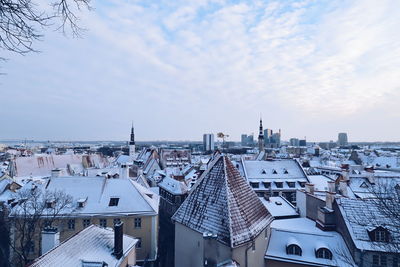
265, 218, 356, 267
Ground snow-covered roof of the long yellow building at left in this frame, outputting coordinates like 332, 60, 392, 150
13, 176, 159, 217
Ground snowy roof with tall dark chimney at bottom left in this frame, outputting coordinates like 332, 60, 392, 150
30, 225, 138, 267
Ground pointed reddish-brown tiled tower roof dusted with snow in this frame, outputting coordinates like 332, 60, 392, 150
172, 155, 272, 247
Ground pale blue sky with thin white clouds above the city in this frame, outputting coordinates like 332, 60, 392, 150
0, 0, 400, 142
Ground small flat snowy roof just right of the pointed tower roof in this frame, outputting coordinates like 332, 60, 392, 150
259, 196, 299, 219
